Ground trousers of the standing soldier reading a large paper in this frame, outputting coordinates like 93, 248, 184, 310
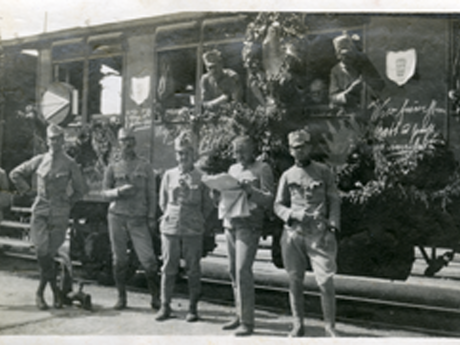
225, 226, 262, 327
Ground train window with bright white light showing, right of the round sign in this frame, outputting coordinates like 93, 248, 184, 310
88, 56, 123, 117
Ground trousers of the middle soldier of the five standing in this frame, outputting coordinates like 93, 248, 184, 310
161, 234, 203, 304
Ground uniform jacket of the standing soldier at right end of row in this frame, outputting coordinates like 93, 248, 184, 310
274, 161, 340, 232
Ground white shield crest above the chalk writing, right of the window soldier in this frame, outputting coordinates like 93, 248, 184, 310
387, 48, 417, 86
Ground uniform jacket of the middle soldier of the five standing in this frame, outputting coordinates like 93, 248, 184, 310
160, 167, 214, 236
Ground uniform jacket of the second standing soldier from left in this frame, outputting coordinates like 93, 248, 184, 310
102, 155, 157, 219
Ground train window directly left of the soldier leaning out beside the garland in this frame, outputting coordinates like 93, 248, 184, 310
156, 49, 197, 122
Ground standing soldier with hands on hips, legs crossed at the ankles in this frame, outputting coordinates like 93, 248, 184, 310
10, 124, 86, 310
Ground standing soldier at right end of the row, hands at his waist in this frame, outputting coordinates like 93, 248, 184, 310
274, 130, 340, 337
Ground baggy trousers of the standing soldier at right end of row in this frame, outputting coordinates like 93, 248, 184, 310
281, 228, 337, 320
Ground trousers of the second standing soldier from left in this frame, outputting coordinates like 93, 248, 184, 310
107, 213, 157, 278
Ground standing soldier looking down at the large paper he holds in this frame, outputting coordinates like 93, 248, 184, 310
214, 136, 274, 336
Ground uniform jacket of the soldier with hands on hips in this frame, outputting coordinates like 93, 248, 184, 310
10, 152, 86, 217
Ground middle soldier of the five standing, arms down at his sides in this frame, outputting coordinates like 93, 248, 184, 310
156, 132, 214, 322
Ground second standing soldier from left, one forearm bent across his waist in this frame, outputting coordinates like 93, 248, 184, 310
103, 128, 159, 310
